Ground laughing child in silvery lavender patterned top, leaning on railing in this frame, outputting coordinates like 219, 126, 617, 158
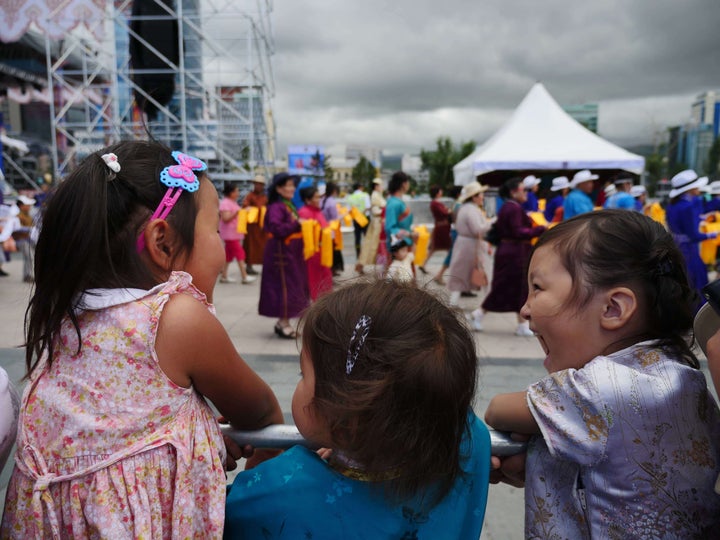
485, 210, 720, 539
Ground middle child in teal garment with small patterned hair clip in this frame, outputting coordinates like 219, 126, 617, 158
225, 281, 490, 540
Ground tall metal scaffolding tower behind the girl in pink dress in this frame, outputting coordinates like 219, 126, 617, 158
45, 0, 275, 180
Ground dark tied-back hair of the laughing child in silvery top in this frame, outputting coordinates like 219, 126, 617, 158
533, 210, 699, 368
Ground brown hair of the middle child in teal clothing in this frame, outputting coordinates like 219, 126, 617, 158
302, 280, 477, 505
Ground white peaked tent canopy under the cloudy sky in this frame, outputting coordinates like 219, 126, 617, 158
453, 83, 645, 186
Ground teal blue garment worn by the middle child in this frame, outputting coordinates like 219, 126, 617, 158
225, 413, 490, 540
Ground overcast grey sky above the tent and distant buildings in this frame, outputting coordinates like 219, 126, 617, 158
272, 0, 720, 154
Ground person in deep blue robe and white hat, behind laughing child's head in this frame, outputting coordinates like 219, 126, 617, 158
666, 169, 717, 301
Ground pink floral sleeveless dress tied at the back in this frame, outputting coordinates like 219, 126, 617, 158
0, 272, 225, 539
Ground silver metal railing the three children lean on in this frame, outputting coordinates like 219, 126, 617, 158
220, 424, 527, 457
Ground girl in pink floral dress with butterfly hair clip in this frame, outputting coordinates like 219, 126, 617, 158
0, 141, 283, 538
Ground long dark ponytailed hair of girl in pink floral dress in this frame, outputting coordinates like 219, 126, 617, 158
25, 141, 202, 374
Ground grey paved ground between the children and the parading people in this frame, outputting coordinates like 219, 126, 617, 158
0, 235, 707, 540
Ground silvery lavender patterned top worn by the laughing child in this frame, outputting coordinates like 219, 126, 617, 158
525, 341, 720, 540
